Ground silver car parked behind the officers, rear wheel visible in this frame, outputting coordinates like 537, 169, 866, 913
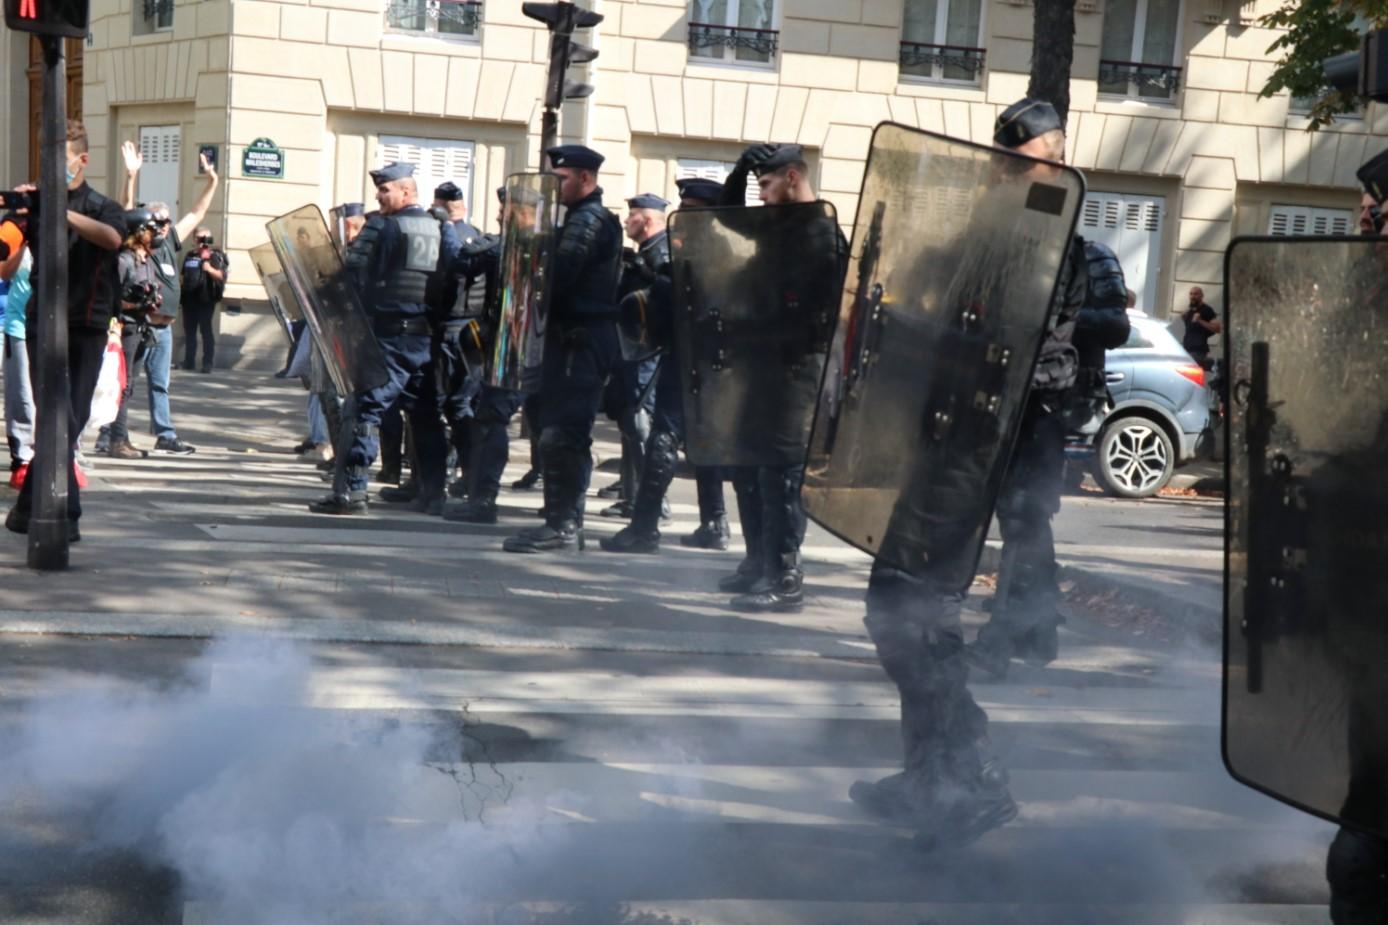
1066, 311, 1210, 497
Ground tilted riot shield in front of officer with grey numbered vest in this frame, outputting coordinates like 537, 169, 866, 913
265, 206, 387, 394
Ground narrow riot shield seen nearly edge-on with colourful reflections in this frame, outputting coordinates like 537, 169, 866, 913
487, 174, 559, 392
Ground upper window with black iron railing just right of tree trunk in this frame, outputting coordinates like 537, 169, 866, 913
1099, 0, 1181, 100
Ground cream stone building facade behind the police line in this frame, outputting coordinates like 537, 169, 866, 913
0, 0, 1388, 329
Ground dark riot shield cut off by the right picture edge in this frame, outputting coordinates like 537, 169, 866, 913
1224, 231, 1388, 835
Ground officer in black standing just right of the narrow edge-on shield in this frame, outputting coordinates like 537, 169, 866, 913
502, 144, 622, 553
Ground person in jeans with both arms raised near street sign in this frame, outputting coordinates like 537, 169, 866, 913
121, 142, 218, 456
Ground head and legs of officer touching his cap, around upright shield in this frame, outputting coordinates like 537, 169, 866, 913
719, 144, 848, 613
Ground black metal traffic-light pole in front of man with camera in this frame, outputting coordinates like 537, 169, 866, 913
29, 36, 72, 571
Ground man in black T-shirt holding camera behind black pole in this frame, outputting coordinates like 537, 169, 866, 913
4, 119, 125, 542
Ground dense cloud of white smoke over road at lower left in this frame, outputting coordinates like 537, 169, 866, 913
0, 638, 564, 925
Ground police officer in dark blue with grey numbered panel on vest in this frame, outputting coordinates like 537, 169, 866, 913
308, 164, 447, 514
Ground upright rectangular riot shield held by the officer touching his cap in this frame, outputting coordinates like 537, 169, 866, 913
669, 201, 847, 467
